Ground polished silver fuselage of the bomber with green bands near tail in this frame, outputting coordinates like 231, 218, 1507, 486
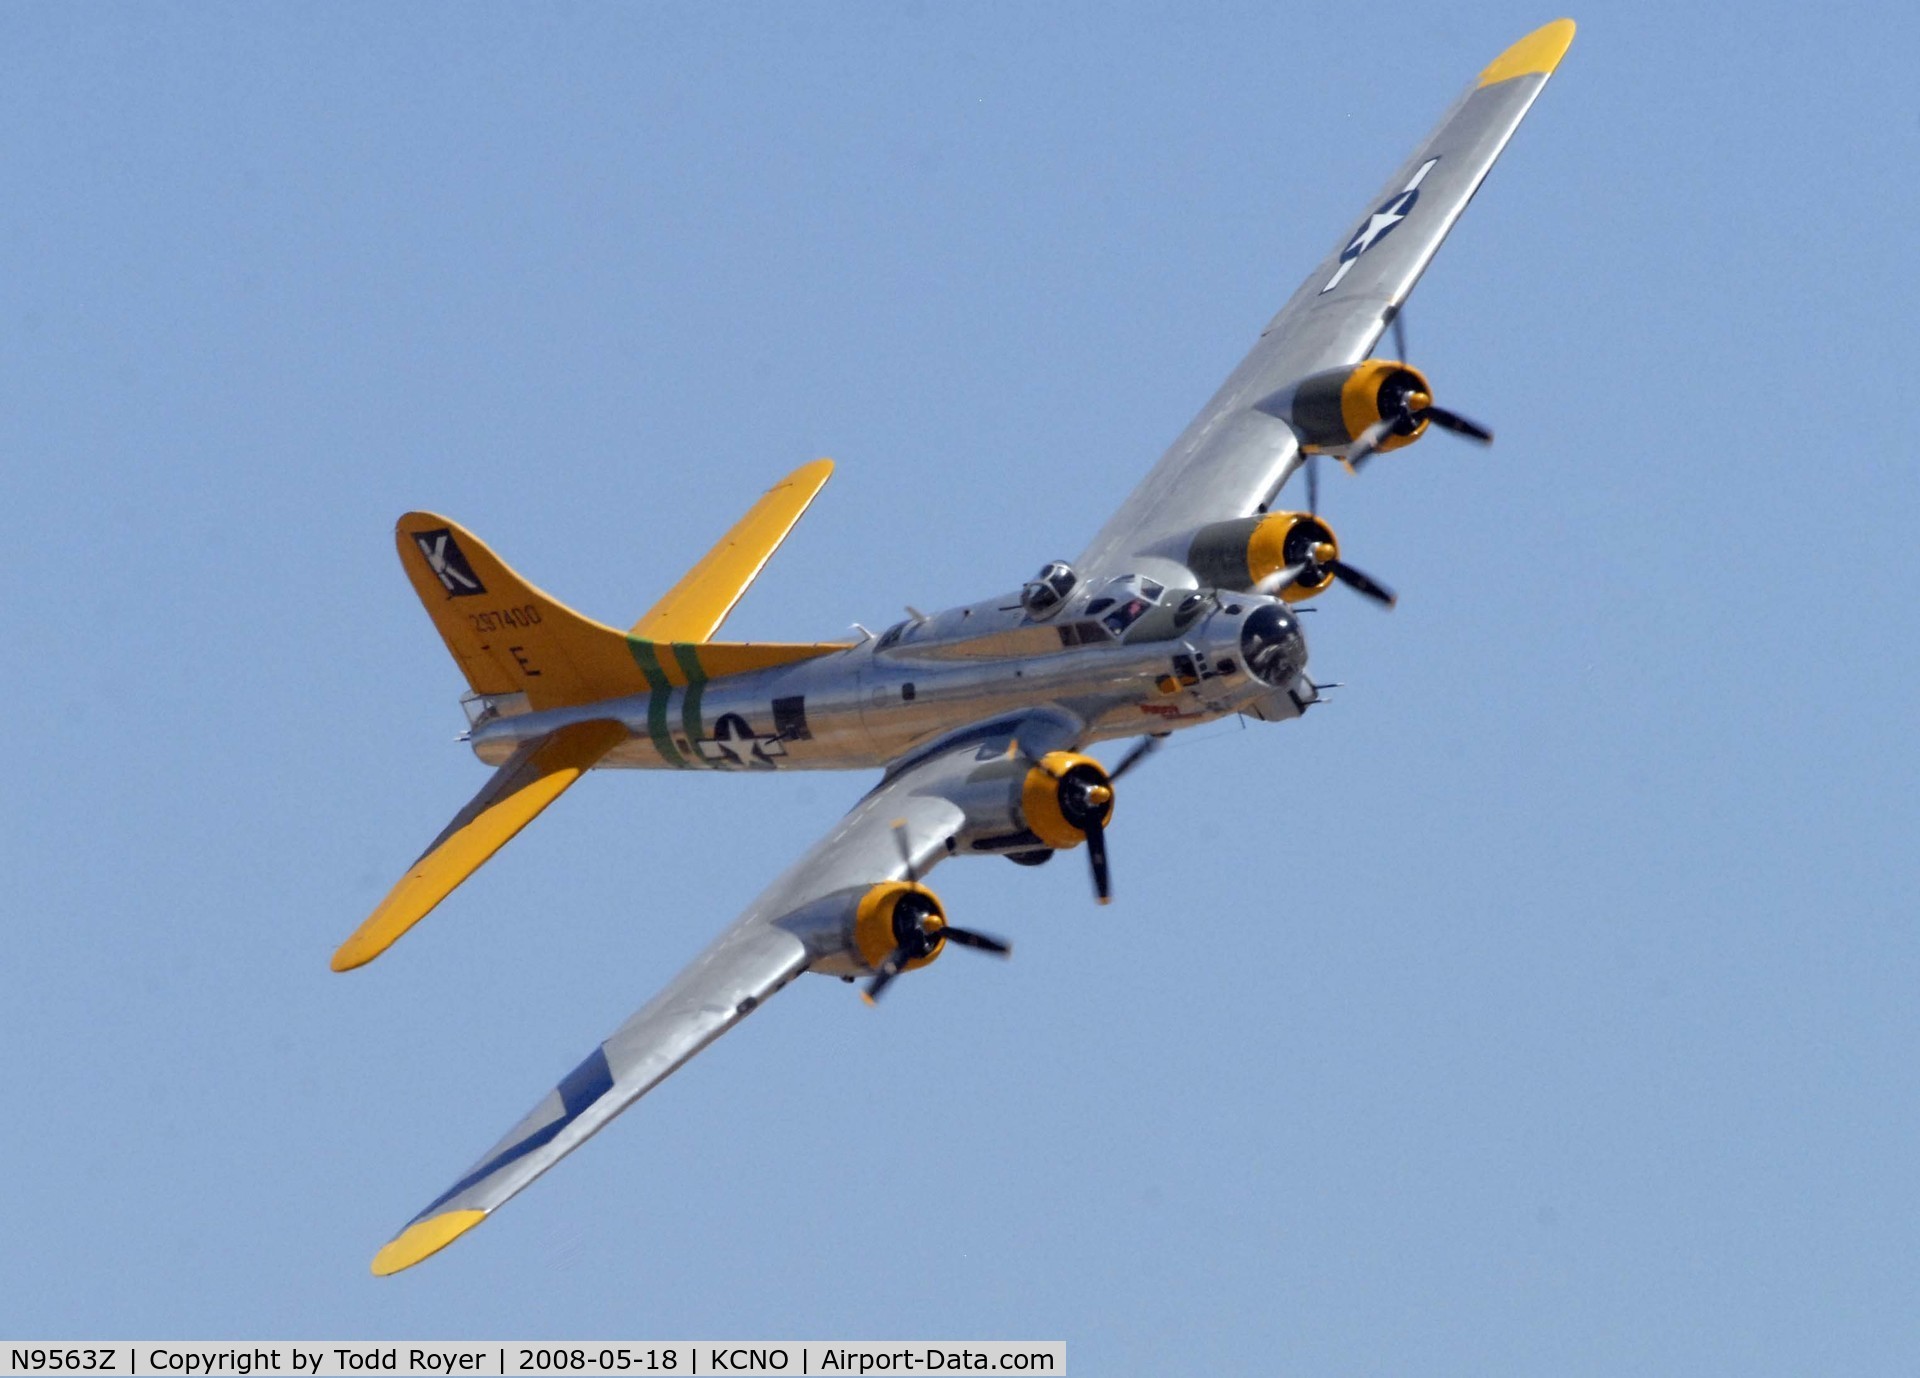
470, 593, 1313, 770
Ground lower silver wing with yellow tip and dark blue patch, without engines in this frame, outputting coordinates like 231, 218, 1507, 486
372, 714, 1077, 1276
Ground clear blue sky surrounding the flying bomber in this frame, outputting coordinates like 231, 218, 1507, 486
0, 4, 1920, 1374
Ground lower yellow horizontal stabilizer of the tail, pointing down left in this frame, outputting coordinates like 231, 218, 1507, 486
332, 722, 626, 971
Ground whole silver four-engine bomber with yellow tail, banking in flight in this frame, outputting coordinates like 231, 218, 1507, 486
345, 19, 1574, 1274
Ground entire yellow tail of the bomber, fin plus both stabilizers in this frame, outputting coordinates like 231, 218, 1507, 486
332, 459, 841, 971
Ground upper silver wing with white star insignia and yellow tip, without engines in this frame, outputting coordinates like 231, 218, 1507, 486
1075, 19, 1574, 580
